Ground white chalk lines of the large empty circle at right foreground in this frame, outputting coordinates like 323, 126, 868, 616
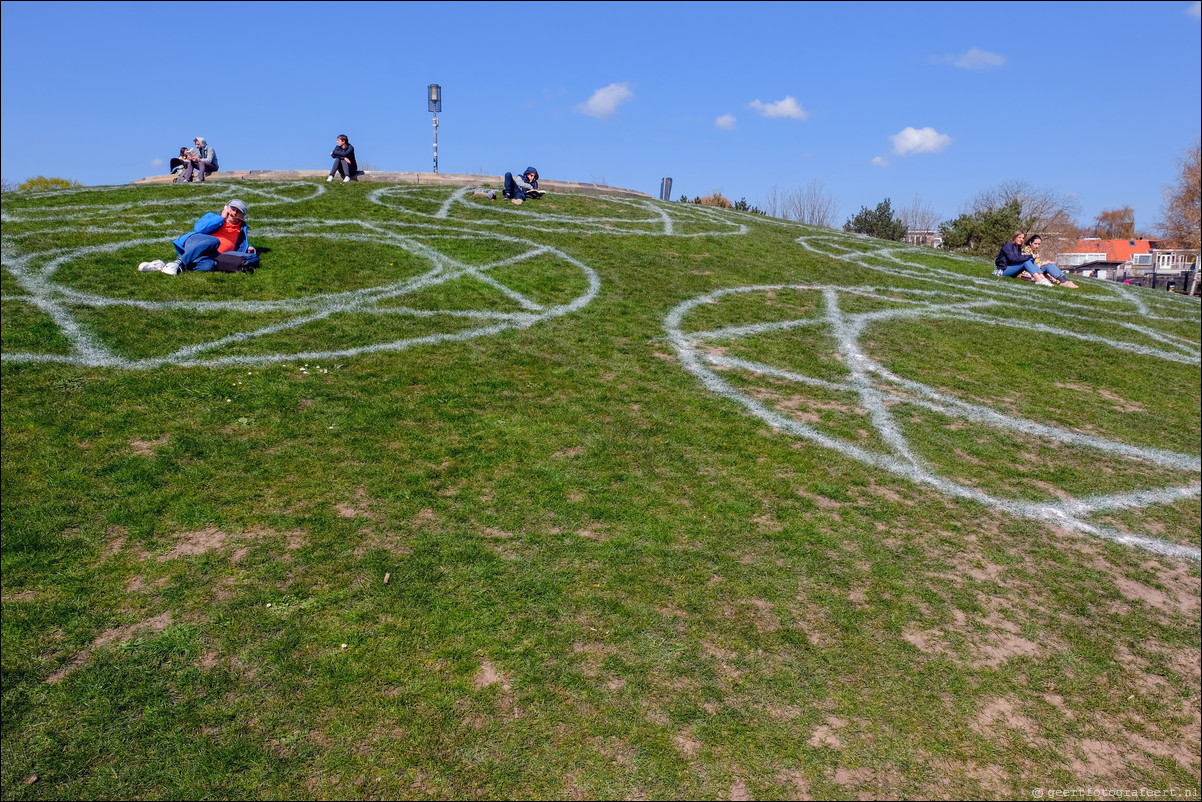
665, 284, 1202, 562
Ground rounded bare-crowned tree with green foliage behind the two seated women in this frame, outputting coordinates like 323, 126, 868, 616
939, 182, 1081, 261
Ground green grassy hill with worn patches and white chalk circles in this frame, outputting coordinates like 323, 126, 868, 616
0, 182, 1202, 800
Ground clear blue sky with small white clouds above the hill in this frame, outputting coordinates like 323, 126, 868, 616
0, 0, 1202, 228
